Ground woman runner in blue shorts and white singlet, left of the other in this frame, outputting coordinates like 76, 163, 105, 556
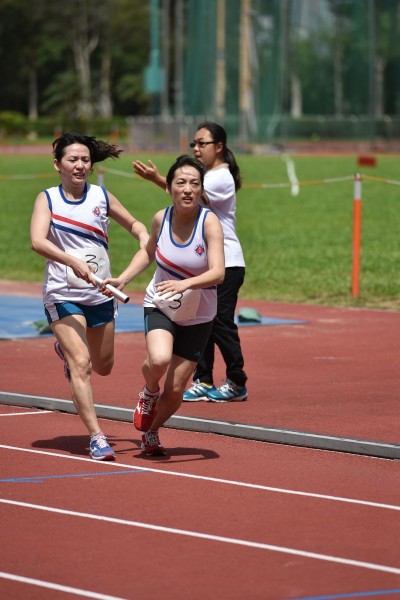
31, 132, 149, 460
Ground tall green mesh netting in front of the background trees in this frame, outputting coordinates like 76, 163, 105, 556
179, 0, 400, 142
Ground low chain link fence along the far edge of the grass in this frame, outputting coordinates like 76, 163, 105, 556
127, 115, 400, 153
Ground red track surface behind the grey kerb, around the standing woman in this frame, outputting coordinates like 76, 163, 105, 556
0, 281, 400, 444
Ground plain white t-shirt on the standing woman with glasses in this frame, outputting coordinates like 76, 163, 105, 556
204, 166, 245, 267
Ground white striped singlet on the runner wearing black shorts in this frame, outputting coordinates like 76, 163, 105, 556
143, 206, 217, 325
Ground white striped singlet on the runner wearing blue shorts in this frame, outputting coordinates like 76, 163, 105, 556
43, 183, 110, 305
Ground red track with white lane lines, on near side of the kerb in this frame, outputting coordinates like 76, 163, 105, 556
0, 406, 400, 600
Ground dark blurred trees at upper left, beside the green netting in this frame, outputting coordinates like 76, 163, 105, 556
0, 0, 149, 122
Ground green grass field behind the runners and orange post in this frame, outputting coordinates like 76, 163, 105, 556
0, 147, 400, 310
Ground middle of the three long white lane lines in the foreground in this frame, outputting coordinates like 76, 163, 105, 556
0, 498, 400, 575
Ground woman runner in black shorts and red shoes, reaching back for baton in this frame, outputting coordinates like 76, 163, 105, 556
103, 155, 225, 456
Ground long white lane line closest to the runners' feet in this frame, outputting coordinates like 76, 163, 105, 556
0, 444, 400, 511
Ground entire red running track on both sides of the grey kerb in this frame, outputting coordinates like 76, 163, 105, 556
0, 285, 400, 600
